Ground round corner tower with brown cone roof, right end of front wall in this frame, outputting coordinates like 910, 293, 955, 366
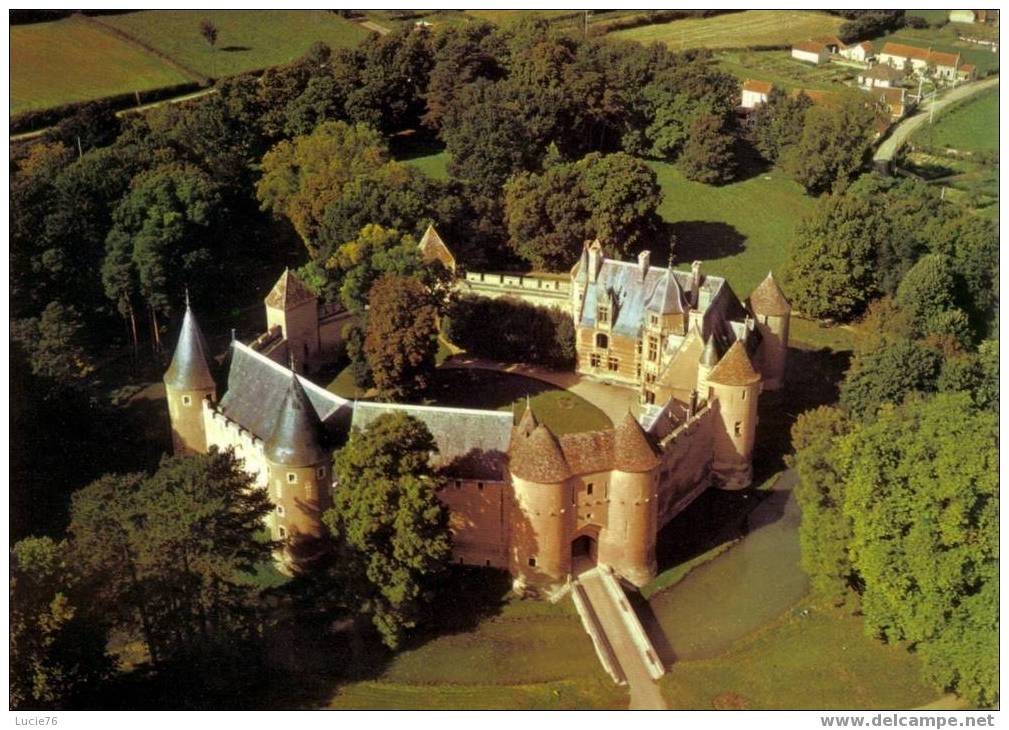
707, 340, 761, 490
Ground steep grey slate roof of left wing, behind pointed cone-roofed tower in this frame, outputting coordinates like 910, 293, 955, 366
218, 341, 350, 442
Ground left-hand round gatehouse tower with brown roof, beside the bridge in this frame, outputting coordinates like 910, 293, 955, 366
509, 420, 575, 586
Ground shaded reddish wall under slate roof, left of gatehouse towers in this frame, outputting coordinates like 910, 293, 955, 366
438, 480, 511, 568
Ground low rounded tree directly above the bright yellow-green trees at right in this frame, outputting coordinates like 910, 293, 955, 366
840, 340, 941, 420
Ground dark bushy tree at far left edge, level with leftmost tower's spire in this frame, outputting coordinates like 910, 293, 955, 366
11, 302, 94, 386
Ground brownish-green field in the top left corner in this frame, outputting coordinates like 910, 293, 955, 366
9, 16, 192, 114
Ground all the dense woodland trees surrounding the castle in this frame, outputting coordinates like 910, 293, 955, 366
10, 13, 998, 707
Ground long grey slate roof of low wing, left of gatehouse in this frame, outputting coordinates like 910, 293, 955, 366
351, 401, 513, 482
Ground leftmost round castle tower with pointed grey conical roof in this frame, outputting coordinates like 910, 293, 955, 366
164, 294, 217, 455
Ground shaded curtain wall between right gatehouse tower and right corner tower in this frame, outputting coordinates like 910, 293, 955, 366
656, 407, 716, 530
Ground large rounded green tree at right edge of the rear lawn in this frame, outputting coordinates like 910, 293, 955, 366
785, 190, 890, 320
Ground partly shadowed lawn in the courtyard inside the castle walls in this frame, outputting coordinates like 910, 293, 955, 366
326, 368, 612, 433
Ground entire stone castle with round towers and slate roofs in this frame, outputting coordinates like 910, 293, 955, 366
164, 234, 791, 591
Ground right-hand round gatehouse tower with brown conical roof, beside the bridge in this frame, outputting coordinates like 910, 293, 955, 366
599, 412, 660, 586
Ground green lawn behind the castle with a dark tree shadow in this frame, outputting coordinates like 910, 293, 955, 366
649, 162, 814, 298
